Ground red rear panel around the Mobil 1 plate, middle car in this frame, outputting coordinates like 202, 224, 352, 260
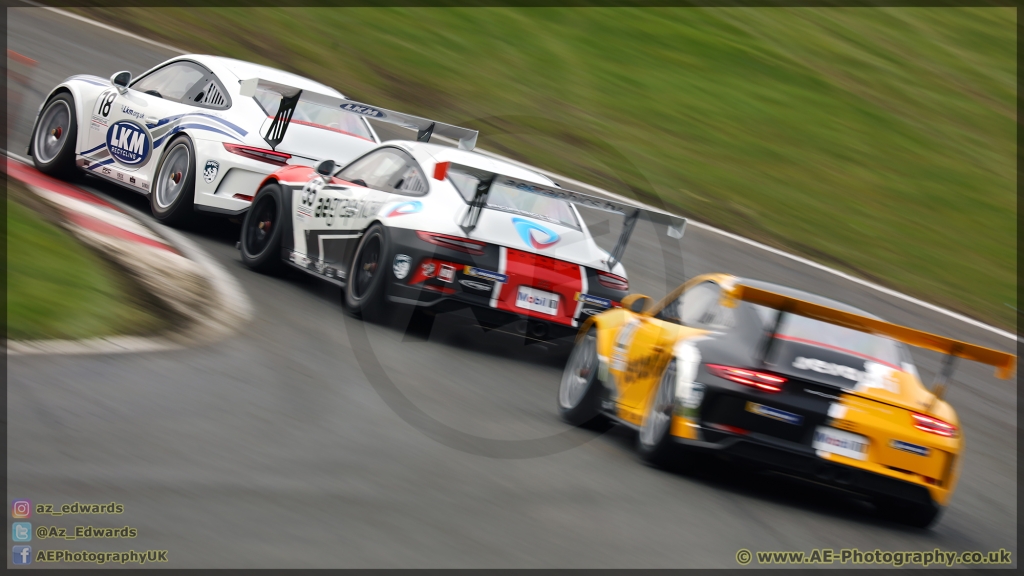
496, 248, 583, 326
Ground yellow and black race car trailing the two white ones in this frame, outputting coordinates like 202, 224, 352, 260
558, 275, 1017, 528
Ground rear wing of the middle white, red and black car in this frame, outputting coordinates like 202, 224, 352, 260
453, 164, 686, 271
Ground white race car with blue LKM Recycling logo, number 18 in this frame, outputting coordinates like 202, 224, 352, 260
28, 54, 465, 222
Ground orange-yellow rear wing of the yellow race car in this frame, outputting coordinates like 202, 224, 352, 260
724, 283, 1017, 379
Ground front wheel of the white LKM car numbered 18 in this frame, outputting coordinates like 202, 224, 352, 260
32, 92, 78, 178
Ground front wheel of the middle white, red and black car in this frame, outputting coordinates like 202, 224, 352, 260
240, 182, 288, 274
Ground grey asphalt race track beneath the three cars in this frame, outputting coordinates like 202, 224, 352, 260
6, 8, 1018, 568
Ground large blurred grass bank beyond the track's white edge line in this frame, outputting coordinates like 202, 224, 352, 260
81, 7, 1017, 329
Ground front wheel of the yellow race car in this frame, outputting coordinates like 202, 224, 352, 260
558, 326, 604, 427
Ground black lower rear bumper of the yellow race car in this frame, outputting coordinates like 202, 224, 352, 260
675, 428, 936, 506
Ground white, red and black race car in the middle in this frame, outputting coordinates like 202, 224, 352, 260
239, 79, 685, 340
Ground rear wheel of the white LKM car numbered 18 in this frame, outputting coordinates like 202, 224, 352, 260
150, 135, 196, 225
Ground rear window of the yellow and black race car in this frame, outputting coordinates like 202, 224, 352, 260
750, 304, 908, 368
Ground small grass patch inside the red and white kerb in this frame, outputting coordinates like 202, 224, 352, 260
6, 181, 163, 340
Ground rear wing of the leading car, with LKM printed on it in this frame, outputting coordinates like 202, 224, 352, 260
239, 78, 478, 150
